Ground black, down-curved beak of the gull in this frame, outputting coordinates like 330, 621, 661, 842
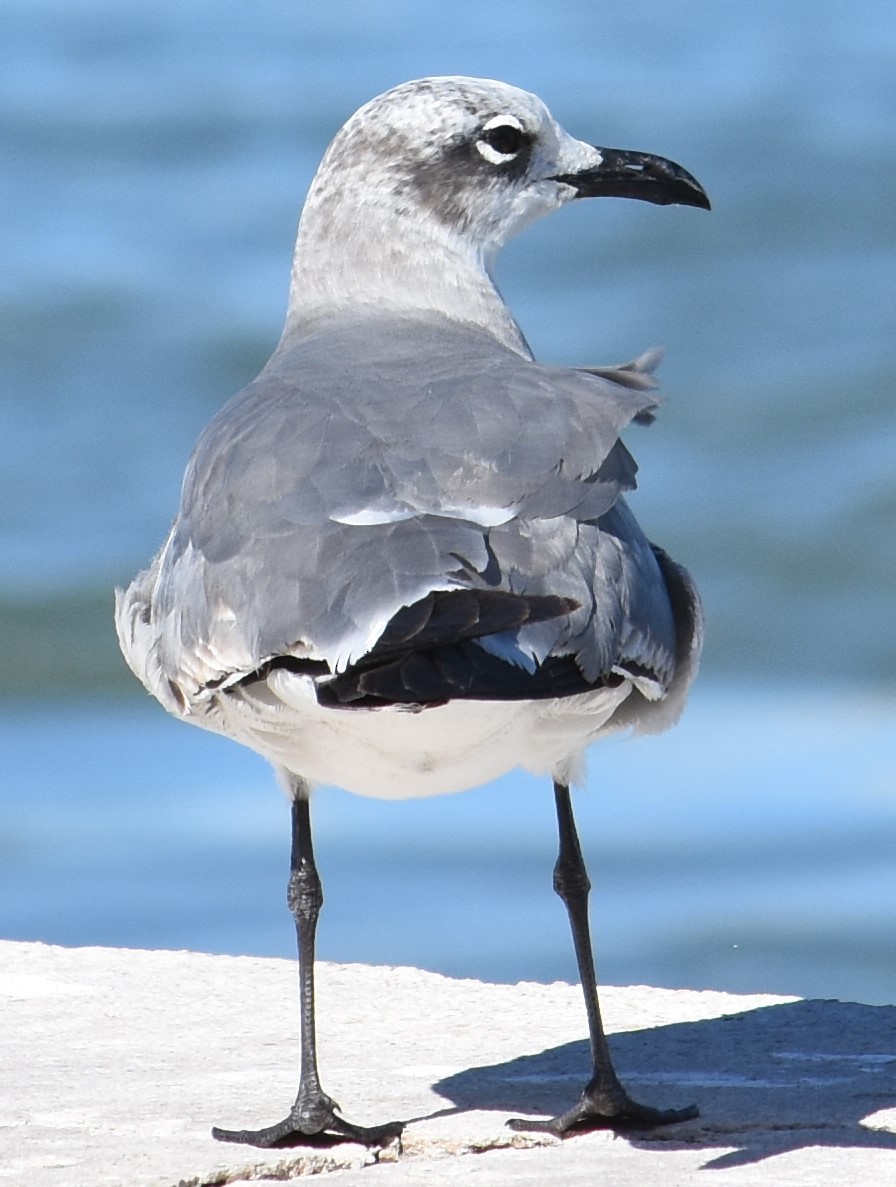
554, 148, 710, 210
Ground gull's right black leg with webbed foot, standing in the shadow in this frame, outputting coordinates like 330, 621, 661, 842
508, 783, 698, 1137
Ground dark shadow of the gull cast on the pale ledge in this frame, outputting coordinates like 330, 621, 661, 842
433, 1001, 896, 1169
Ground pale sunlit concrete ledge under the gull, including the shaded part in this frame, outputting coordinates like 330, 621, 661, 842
0, 942, 896, 1187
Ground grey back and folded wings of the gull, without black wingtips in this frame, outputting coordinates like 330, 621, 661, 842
119, 310, 693, 704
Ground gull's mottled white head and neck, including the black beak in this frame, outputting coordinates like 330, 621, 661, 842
292, 77, 708, 344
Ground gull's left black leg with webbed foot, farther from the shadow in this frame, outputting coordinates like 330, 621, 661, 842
211, 794, 402, 1148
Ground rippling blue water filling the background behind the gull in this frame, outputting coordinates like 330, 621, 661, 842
0, 0, 896, 1002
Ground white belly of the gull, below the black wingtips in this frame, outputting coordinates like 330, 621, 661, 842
205, 669, 631, 799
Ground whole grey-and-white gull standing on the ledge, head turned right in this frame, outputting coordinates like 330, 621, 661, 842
115, 77, 710, 1147
